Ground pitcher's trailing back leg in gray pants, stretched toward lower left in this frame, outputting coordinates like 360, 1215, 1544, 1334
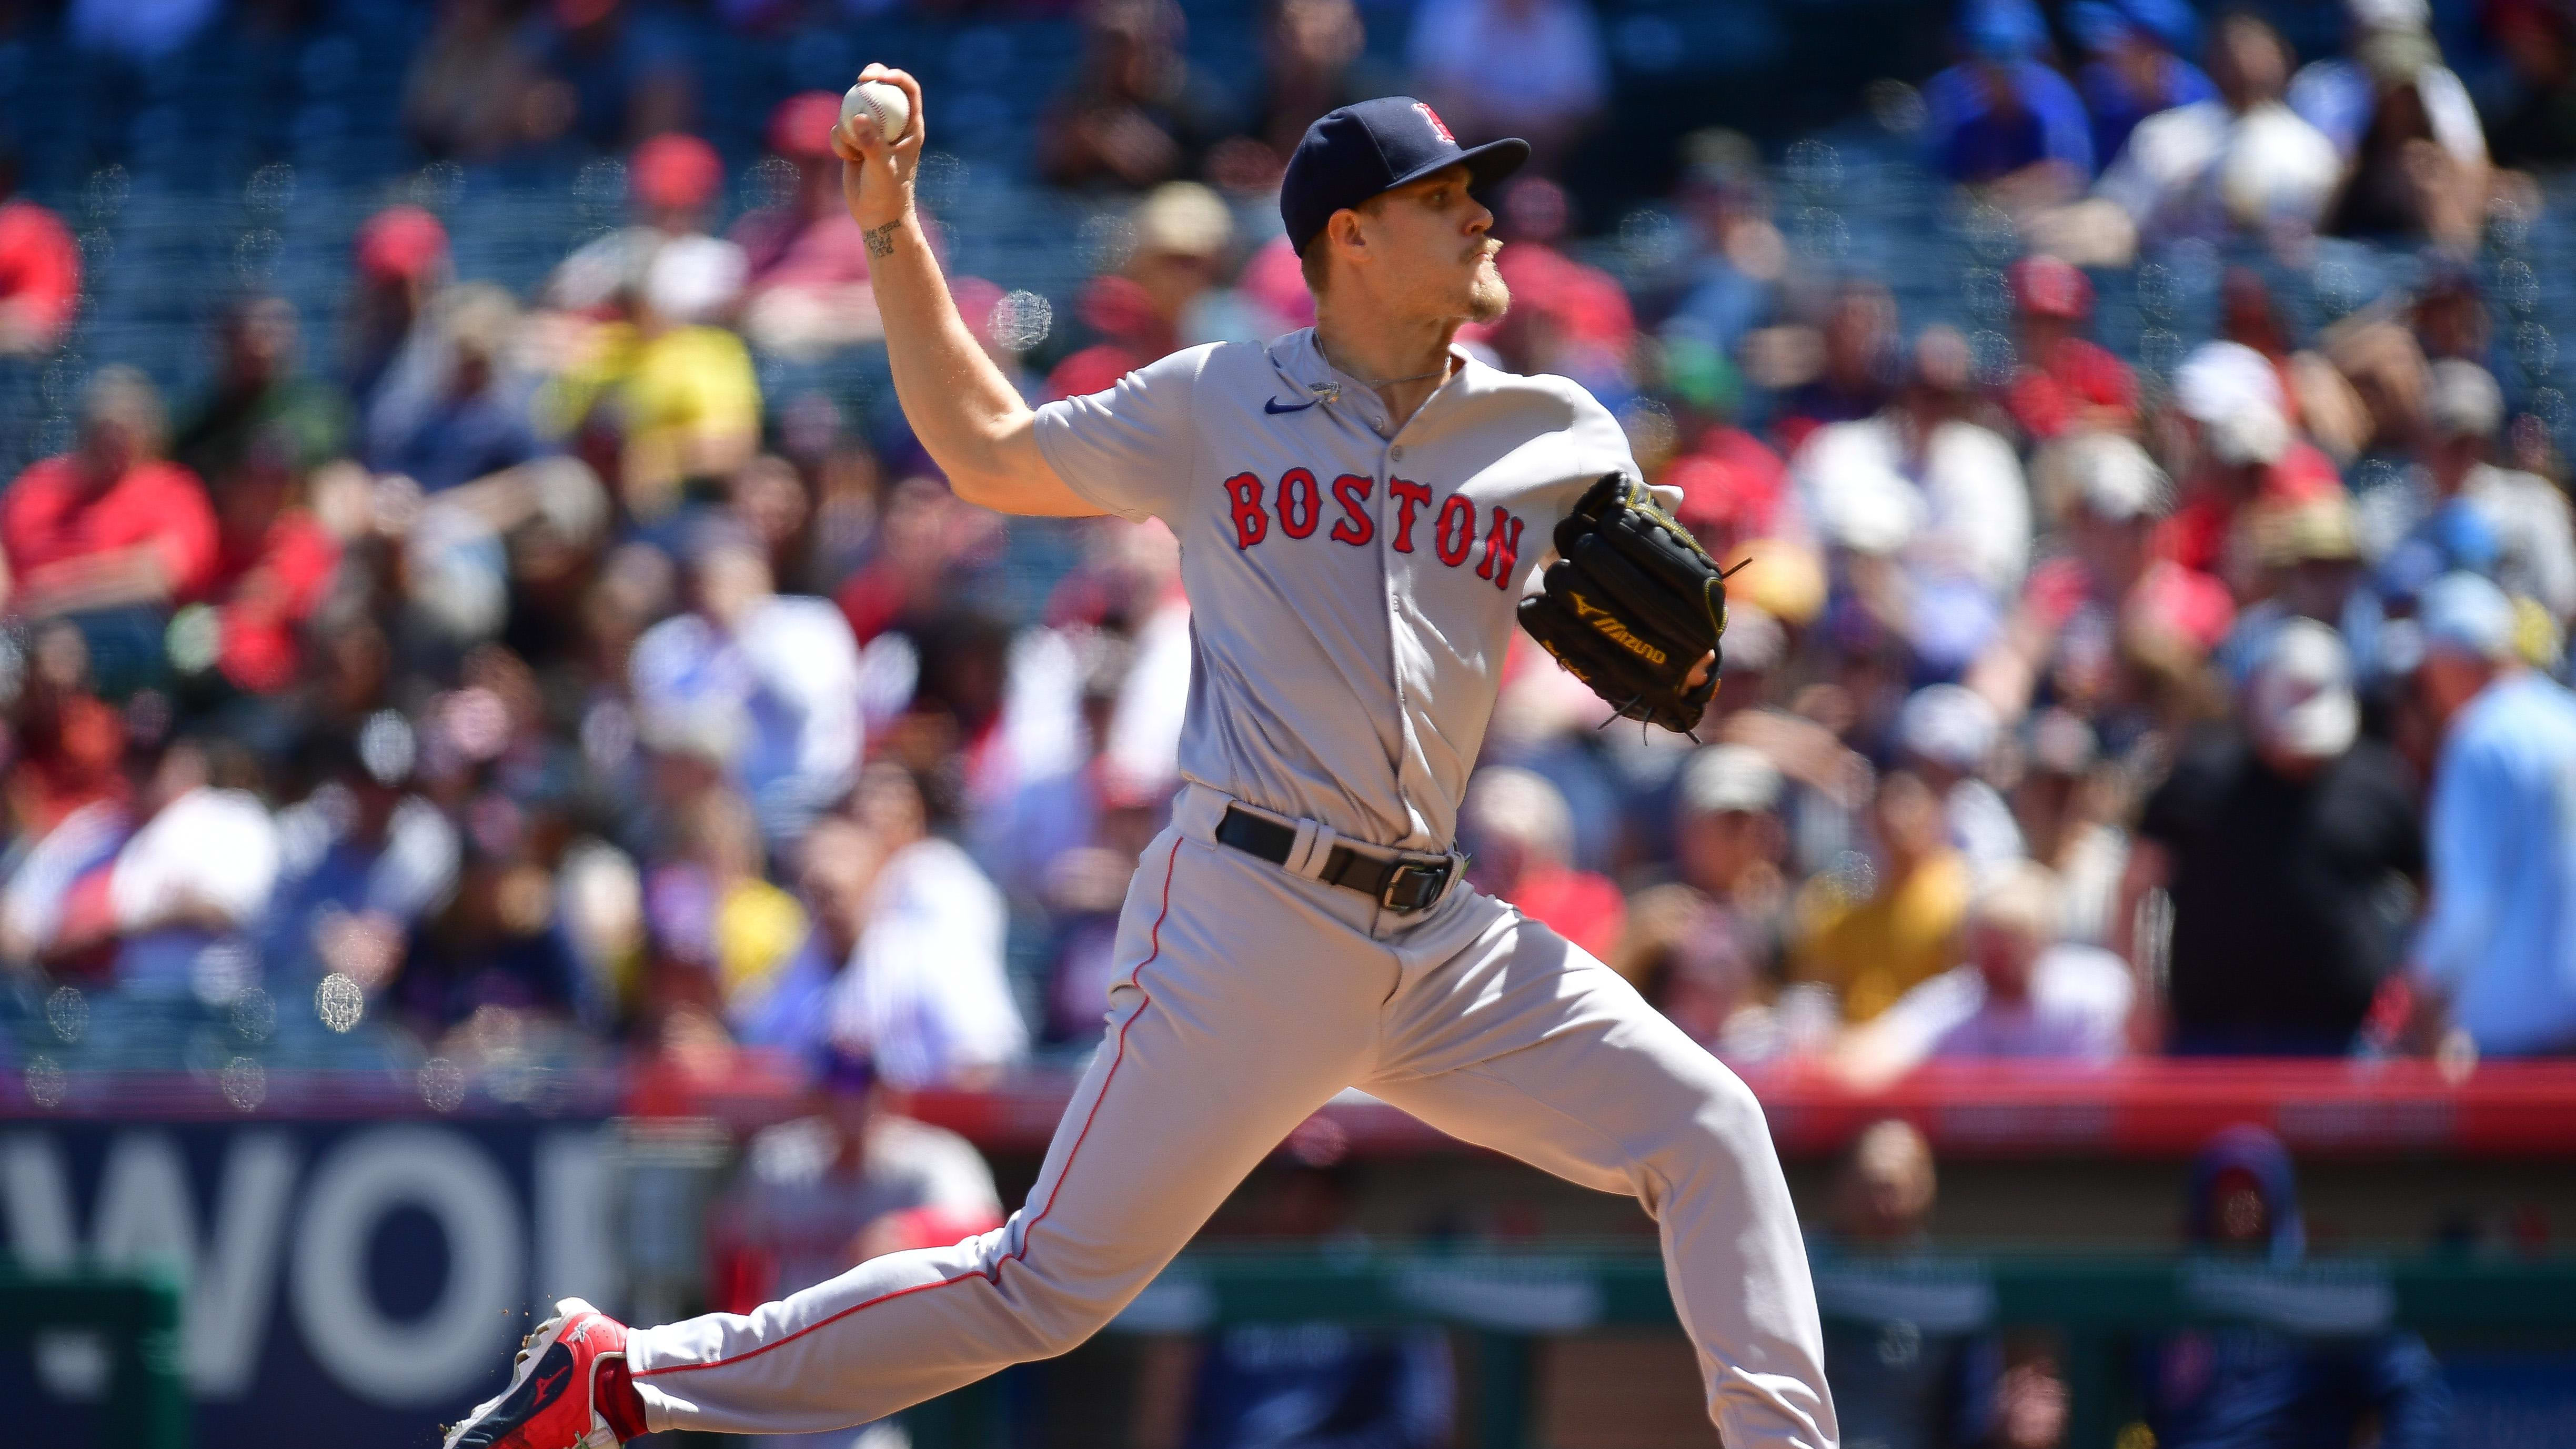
626, 836, 1394, 1434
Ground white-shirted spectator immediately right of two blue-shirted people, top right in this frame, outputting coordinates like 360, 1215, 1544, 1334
2094, 11, 2344, 250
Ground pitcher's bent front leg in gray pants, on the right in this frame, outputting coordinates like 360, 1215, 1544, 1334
1360, 902, 1837, 1449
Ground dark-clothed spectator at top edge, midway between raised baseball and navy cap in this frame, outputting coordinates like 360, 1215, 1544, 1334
1035, 0, 1226, 191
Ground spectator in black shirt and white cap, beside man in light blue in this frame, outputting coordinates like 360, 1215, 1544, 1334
2112, 619, 2424, 1057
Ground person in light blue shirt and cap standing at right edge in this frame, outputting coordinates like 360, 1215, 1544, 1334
2411, 572, 2576, 1057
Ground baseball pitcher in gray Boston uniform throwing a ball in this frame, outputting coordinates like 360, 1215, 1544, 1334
446, 67, 1837, 1449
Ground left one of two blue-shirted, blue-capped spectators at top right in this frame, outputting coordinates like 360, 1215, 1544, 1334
1924, 0, 2094, 194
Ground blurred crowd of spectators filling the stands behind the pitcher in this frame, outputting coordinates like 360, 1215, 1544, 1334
0, 0, 2576, 1088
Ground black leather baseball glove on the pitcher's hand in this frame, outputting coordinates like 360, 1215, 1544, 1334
1520, 472, 1726, 735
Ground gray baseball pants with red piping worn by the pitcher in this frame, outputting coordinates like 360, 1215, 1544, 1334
626, 787, 1837, 1449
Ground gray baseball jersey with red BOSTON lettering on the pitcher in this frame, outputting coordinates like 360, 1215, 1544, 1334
1038, 330, 1636, 851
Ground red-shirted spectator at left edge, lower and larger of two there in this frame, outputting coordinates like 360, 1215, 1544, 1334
0, 366, 216, 619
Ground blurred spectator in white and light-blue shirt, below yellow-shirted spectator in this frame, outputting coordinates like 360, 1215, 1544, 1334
629, 521, 863, 843
